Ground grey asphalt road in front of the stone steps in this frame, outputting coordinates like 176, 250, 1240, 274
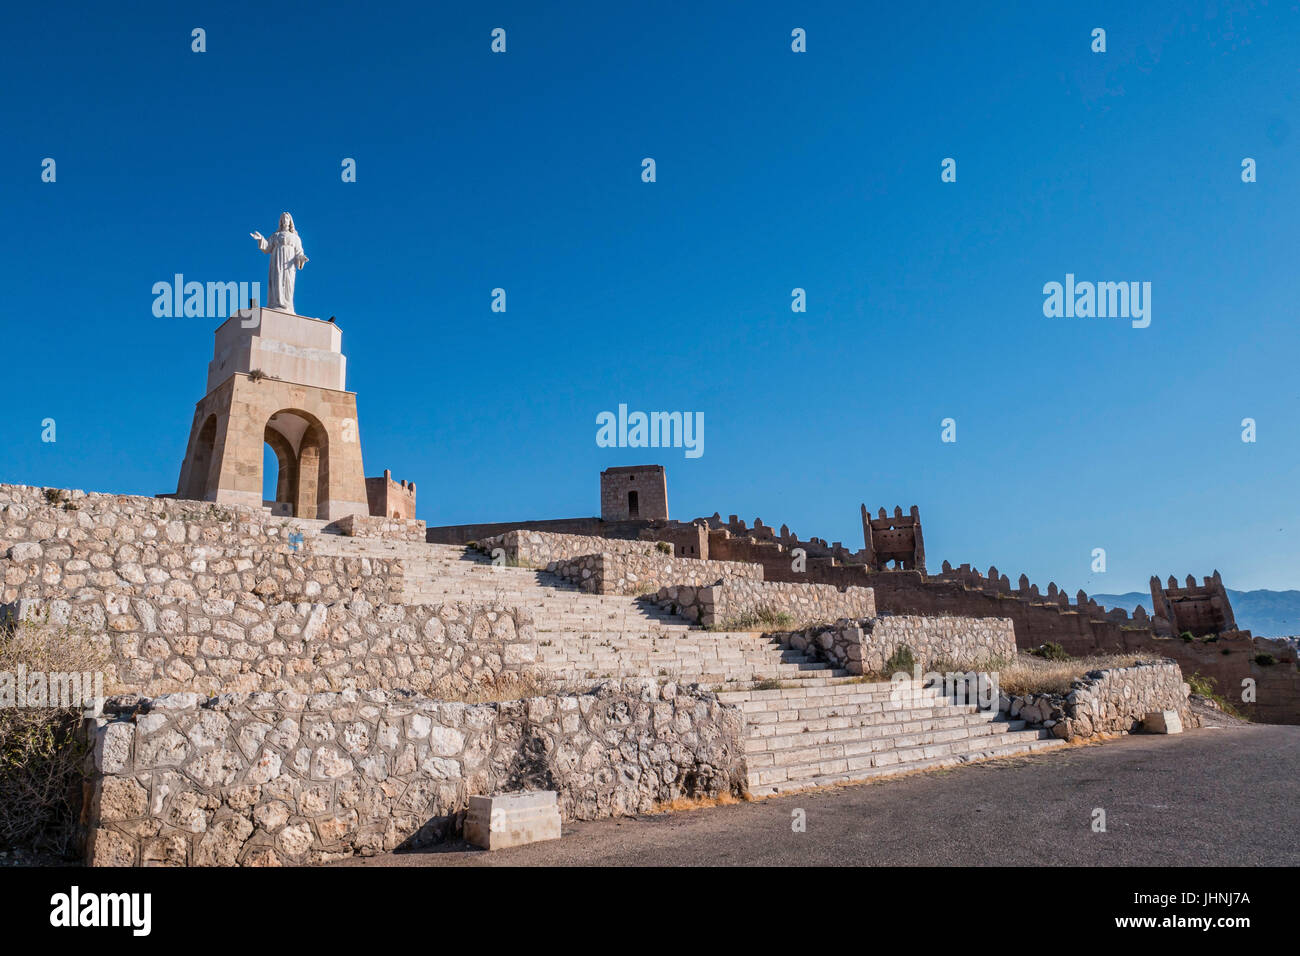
338, 724, 1300, 866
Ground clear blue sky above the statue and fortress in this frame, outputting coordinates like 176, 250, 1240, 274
0, 3, 1300, 592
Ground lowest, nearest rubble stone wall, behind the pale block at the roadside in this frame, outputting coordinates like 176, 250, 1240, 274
86, 679, 745, 866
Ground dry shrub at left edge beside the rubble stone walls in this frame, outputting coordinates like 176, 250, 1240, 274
0, 622, 111, 855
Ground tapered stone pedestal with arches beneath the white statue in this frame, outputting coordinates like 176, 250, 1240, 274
176, 306, 371, 520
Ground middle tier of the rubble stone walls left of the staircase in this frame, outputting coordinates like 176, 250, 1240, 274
17, 594, 538, 695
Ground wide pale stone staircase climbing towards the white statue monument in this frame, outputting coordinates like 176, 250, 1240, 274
302, 523, 1061, 796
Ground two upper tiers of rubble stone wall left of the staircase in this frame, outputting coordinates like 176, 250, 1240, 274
0, 485, 537, 695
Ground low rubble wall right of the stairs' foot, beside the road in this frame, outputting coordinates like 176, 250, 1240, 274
1001, 659, 1200, 740
